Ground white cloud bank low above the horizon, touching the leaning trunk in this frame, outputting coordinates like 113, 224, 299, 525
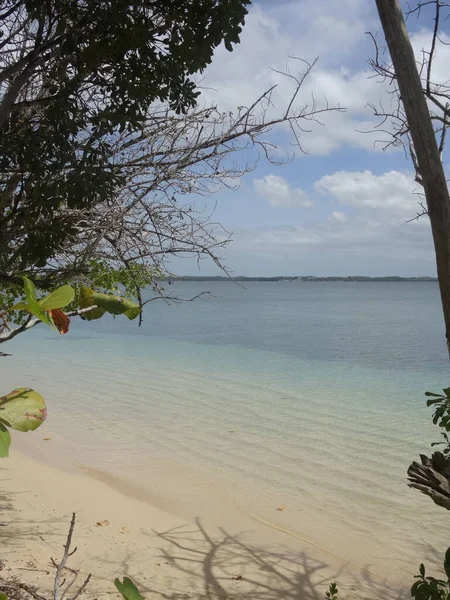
233, 171, 434, 273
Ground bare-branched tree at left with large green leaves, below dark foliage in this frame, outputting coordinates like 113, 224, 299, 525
0, 39, 341, 456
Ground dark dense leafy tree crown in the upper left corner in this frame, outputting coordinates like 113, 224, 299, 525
0, 0, 250, 282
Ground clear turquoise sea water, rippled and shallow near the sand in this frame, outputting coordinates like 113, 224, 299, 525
0, 282, 450, 576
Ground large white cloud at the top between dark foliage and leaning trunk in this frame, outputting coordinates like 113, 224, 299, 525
199, 0, 392, 155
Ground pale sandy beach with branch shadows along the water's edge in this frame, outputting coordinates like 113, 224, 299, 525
0, 442, 410, 600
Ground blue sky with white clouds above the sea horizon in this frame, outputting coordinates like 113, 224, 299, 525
172, 0, 450, 276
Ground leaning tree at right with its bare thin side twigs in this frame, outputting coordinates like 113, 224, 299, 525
373, 0, 450, 352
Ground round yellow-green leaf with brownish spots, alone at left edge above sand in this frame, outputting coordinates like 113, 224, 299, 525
0, 388, 47, 431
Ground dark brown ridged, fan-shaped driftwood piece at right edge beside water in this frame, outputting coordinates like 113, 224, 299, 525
408, 452, 450, 510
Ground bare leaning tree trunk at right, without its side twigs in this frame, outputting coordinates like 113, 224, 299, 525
376, 0, 450, 352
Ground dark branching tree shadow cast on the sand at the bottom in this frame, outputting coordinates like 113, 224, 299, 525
96, 519, 409, 600
